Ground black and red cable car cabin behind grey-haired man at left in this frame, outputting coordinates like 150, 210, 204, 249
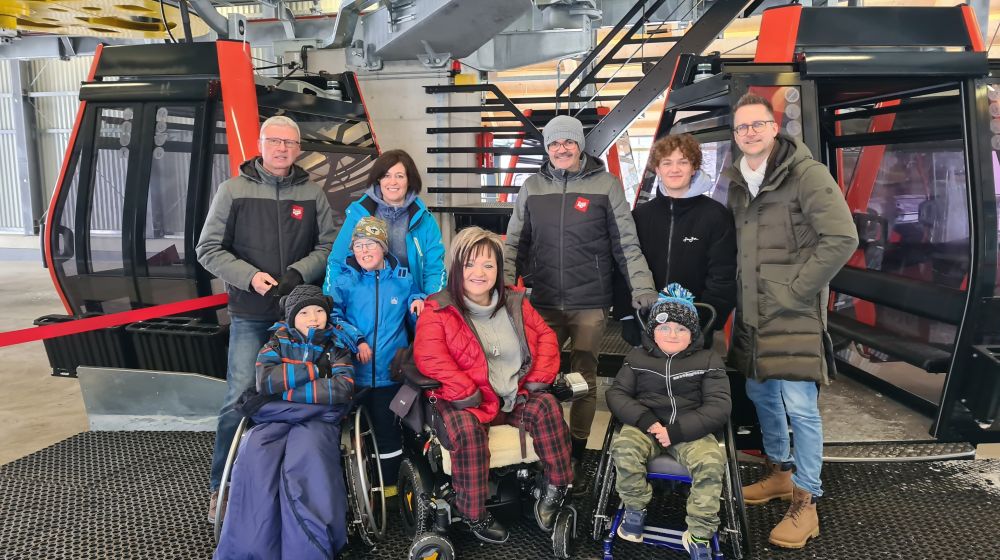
43, 41, 378, 317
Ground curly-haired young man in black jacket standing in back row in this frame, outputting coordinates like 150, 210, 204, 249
614, 134, 736, 348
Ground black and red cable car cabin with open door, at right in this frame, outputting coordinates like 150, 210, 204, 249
638, 5, 1000, 441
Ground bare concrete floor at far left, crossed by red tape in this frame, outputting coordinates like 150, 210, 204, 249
0, 259, 87, 464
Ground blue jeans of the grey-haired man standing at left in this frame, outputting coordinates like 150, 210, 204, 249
209, 316, 274, 492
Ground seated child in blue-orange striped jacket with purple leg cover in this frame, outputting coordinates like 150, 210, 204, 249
214, 284, 354, 560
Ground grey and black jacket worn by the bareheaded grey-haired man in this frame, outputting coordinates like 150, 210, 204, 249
196, 157, 337, 320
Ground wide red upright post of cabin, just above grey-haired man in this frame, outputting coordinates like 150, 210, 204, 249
216, 41, 260, 177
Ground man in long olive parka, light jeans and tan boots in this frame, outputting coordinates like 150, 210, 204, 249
725, 94, 858, 548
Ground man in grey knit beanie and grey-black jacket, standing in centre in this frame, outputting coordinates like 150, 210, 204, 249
504, 115, 657, 494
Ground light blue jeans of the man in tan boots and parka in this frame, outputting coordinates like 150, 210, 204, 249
747, 379, 823, 497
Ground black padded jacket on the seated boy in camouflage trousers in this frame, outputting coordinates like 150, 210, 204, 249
605, 337, 732, 443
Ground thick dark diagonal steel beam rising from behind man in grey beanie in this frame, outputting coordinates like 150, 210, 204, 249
587, 0, 753, 156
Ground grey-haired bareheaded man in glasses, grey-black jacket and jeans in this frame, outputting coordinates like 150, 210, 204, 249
196, 116, 336, 521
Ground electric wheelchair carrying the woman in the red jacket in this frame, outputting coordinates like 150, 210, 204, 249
397, 369, 586, 560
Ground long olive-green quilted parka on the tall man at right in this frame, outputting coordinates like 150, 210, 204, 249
724, 134, 858, 384
